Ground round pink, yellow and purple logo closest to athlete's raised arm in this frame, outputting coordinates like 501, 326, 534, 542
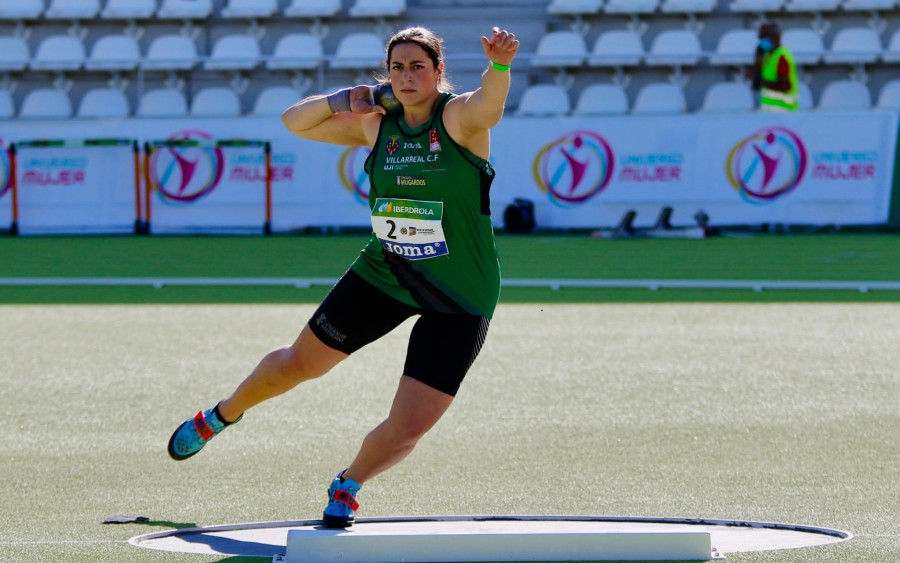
532, 130, 614, 207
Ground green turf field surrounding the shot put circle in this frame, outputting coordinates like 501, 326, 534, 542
0, 234, 900, 563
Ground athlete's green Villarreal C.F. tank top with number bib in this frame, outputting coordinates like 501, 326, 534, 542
351, 93, 500, 318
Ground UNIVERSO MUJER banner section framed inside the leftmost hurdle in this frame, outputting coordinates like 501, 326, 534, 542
16, 139, 136, 234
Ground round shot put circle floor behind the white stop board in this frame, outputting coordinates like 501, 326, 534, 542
128, 516, 853, 558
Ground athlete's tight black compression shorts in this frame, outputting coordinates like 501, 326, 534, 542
309, 270, 490, 396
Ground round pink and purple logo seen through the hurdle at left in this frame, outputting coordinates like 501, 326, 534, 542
150, 130, 225, 204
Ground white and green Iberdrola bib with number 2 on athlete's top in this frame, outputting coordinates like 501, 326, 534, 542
372, 198, 450, 260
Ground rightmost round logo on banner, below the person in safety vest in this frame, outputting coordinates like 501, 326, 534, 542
725, 127, 808, 203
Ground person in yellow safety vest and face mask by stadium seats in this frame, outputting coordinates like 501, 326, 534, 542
748, 21, 799, 111
